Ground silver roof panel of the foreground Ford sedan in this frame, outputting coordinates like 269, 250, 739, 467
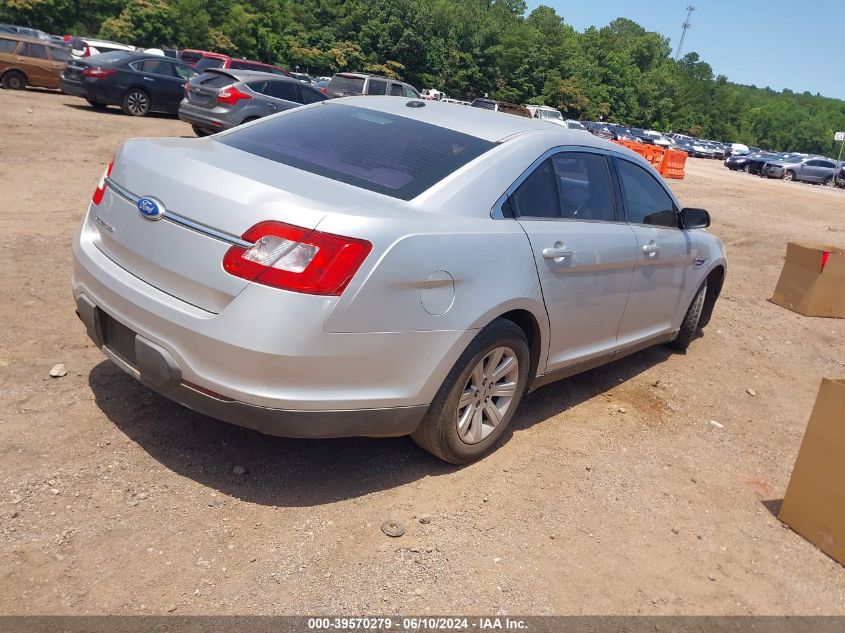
321, 96, 620, 150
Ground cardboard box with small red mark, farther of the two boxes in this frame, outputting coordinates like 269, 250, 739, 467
772, 242, 845, 318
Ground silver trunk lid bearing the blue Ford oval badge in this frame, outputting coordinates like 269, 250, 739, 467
85, 139, 345, 313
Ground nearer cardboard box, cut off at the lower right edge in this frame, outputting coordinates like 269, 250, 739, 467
778, 378, 845, 565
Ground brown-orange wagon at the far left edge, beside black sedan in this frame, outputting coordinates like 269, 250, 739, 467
0, 33, 71, 90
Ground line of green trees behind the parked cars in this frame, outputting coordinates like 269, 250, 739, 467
6, 0, 845, 154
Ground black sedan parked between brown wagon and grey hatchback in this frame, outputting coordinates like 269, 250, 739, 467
59, 51, 199, 116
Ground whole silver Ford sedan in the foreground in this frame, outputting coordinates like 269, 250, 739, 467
73, 97, 726, 463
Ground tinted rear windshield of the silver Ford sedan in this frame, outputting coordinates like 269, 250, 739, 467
219, 104, 494, 200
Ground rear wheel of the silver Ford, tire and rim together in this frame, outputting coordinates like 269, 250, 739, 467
411, 319, 530, 464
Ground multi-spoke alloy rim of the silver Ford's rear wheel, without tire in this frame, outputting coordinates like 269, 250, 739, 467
457, 347, 519, 444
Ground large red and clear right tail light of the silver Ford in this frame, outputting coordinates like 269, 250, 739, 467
223, 222, 373, 296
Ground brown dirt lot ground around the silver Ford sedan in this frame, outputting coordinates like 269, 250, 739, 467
0, 91, 845, 614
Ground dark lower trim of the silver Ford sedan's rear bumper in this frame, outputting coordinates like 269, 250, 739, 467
76, 294, 428, 438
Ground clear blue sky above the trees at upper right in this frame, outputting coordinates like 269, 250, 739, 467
528, 0, 845, 99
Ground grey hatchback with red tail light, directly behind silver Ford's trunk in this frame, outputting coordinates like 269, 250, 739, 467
179, 69, 328, 136
